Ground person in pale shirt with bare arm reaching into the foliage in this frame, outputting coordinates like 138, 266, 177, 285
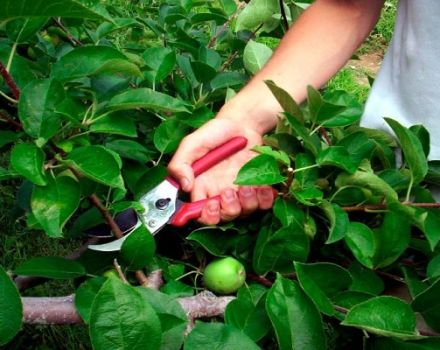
169, 0, 440, 224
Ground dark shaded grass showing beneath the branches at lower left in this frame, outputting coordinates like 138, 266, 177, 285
0, 153, 91, 350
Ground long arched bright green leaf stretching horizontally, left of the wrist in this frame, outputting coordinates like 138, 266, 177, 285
107, 88, 188, 112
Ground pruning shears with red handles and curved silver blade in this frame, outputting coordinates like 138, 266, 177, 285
89, 136, 247, 252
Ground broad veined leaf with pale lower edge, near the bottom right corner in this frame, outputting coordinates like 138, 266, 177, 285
342, 296, 418, 339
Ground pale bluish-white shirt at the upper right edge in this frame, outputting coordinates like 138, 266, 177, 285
362, 0, 440, 159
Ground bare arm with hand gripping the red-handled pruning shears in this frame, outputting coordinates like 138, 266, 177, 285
168, 0, 384, 224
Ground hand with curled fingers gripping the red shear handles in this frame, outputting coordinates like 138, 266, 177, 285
168, 118, 274, 225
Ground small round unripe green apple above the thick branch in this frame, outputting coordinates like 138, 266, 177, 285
203, 257, 246, 294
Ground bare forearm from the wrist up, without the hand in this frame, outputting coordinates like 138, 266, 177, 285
219, 0, 383, 133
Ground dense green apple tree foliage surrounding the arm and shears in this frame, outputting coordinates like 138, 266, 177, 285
0, 0, 440, 350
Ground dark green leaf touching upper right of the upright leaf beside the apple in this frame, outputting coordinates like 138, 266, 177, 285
294, 262, 352, 316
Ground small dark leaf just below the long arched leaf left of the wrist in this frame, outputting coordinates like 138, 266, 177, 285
90, 113, 137, 137
